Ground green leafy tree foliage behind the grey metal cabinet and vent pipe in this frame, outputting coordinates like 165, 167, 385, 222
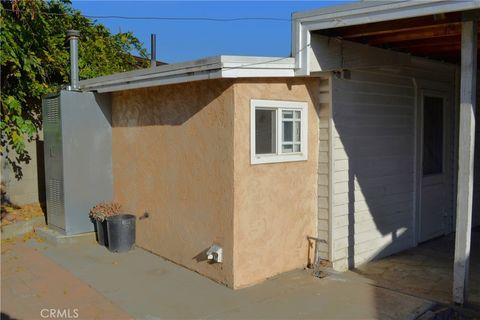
0, 0, 147, 179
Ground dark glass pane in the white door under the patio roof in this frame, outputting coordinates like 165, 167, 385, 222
423, 96, 443, 176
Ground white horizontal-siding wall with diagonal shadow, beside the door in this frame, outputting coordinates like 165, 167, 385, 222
331, 65, 454, 270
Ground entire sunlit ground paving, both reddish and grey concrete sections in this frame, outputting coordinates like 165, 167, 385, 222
1, 232, 433, 319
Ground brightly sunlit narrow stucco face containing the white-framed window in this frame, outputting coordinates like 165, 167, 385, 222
234, 78, 319, 288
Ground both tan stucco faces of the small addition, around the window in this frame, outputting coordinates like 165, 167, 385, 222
112, 78, 320, 288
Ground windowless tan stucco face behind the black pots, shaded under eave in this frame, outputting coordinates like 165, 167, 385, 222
112, 80, 235, 286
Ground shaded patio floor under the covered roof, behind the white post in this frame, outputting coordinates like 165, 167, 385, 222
354, 228, 480, 310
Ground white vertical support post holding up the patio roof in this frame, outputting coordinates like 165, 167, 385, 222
453, 19, 477, 304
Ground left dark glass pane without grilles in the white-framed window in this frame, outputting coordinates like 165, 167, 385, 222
255, 109, 277, 154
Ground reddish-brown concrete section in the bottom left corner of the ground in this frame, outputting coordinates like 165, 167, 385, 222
1, 240, 130, 320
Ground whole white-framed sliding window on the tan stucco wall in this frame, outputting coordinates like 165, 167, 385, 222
250, 100, 308, 164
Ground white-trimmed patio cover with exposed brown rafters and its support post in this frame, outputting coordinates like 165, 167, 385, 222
292, 0, 480, 304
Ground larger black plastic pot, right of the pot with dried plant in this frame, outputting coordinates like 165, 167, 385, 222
107, 214, 136, 252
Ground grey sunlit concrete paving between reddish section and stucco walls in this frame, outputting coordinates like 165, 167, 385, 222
22, 241, 432, 319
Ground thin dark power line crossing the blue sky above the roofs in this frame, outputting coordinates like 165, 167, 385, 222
4, 9, 292, 22
